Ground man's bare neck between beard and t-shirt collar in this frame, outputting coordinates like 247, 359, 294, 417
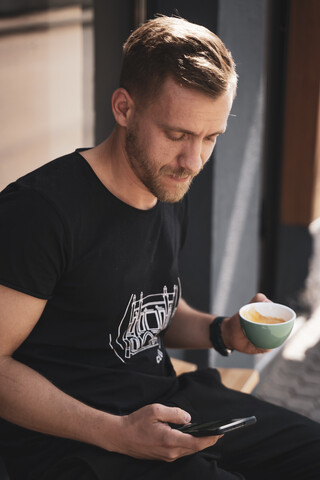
81, 126, 157, 210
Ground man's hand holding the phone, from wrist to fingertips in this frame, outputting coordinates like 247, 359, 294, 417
107, 404, 220, 462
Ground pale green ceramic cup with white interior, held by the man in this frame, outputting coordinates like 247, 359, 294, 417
239, 302, 296, 349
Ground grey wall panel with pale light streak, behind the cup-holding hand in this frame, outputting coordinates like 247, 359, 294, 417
210, 0, 267, 366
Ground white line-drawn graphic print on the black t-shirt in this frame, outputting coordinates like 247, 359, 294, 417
109, 278, 181, 363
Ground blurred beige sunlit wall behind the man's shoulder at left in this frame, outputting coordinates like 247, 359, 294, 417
0, 7, 93, 190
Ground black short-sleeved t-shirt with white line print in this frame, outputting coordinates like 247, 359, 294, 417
0, 151, 186, 428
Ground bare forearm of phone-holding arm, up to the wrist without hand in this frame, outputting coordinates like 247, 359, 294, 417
0, 356, 121, 450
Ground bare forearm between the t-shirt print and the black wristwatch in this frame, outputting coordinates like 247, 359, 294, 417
164, 299, 214, 349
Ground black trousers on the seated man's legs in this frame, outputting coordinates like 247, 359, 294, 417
4, 369, 320, 480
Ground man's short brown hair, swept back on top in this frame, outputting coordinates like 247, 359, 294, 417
120, 16, 237, 101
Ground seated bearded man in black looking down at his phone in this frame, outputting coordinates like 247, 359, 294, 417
0, 17, 320, 480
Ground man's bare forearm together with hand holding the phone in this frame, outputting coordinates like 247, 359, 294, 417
0, 357, 219, 461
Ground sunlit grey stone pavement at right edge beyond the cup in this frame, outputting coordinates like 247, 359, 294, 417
254, 220, 320, 422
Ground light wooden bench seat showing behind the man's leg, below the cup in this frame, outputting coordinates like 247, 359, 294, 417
171, 358, 259, 393
